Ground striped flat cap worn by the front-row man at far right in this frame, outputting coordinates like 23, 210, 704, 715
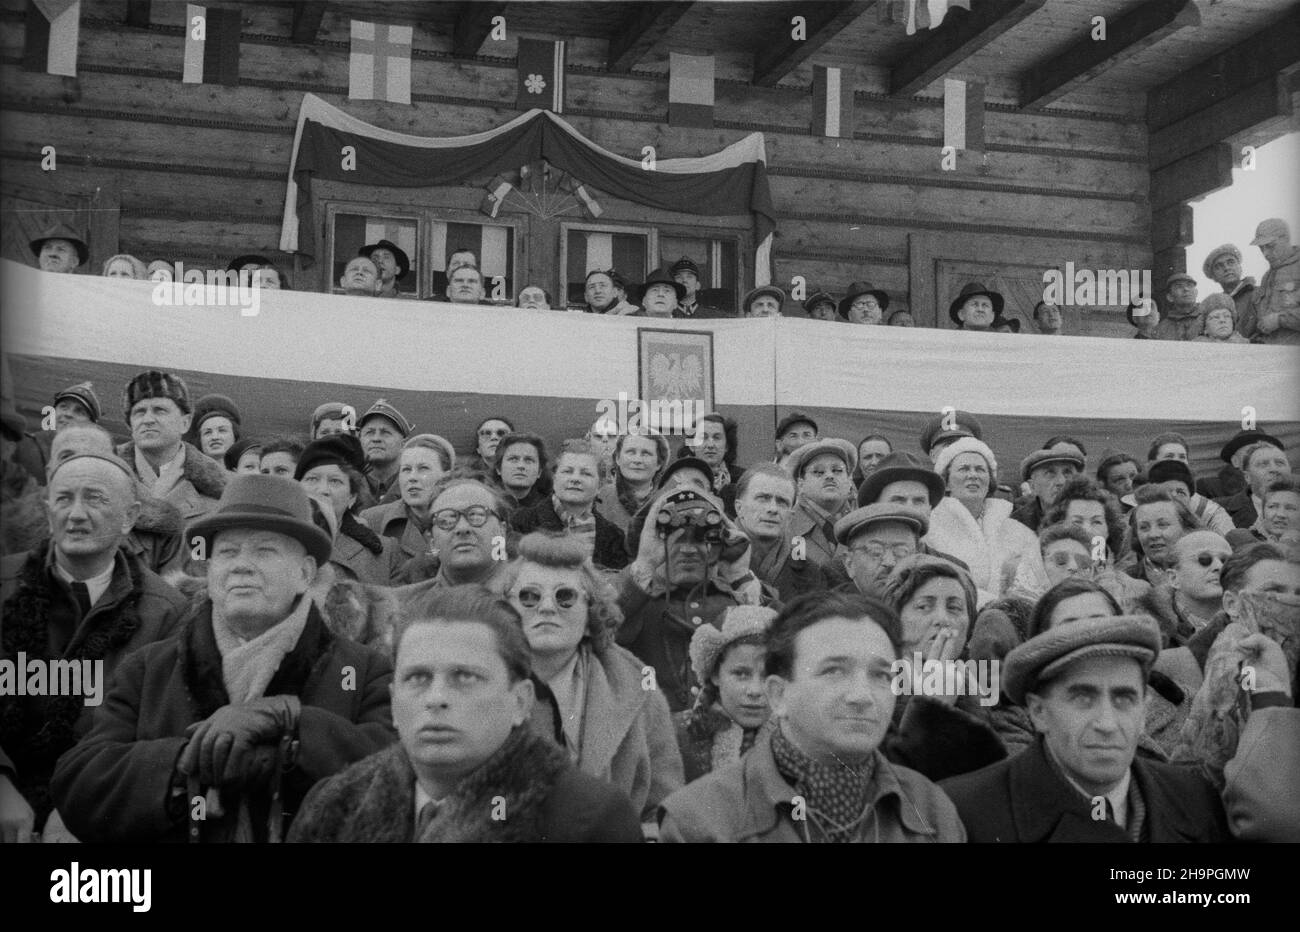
1002, 615, 1160, 706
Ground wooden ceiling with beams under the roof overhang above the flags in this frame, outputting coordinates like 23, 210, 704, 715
121, 0, 1300, 110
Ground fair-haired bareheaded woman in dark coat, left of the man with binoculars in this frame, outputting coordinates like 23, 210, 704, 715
510, 441, 631, 569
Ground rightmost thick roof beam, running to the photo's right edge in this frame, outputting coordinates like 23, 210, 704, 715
1147, 6, 1300, 131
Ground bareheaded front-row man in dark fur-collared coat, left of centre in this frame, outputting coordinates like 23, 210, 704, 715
289, 586, 642, 842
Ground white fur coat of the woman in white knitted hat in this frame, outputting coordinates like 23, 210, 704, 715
926, 498, 1047, 606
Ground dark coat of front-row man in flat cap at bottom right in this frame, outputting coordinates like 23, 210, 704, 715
940, 738, 1229, 844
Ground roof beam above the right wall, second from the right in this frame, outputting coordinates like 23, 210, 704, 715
1021, 0, 1201, 108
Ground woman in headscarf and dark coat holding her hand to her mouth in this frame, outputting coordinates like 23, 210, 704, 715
881, 554, 1006, 780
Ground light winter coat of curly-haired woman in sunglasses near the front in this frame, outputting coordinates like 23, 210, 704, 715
533, 645, 684, 822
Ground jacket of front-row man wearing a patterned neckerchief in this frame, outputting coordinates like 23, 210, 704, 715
659, 734, 966, 844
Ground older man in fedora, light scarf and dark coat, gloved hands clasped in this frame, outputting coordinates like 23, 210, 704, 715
52, 474, 394, 842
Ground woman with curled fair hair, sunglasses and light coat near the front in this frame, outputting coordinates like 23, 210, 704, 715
503, 533, 683, 828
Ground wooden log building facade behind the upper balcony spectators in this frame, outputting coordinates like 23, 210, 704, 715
0, 0, 1300, 337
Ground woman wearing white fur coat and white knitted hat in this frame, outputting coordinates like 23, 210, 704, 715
926, 437, 1040, 607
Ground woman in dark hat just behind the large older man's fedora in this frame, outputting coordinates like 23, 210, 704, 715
294, 434, 402, 586
